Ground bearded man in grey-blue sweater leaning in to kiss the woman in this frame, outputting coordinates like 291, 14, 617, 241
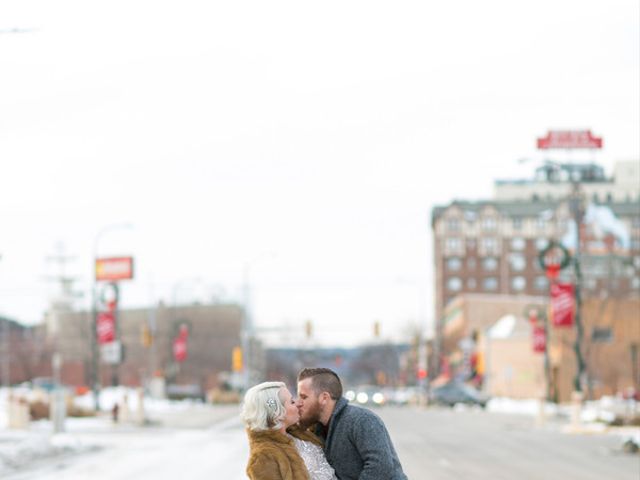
298, 368, 407, 480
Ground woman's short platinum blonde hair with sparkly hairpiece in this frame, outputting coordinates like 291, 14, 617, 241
240, 382, 287, 431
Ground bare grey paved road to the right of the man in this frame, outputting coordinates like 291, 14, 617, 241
378, 408, 640, 480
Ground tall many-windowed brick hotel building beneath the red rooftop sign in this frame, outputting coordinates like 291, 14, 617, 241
431, 162, 640, 324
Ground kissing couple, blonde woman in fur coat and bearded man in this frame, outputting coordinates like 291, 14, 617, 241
241, 368, 407, 480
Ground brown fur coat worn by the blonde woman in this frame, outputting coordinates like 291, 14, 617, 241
247, 427, 322, 480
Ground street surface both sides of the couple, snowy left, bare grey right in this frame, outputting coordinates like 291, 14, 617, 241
7, 406, 640, 480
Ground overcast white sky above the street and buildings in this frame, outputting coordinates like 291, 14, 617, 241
0, 0, 640, 344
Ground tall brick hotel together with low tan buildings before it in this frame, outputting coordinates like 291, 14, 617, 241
431, 161, 640, 401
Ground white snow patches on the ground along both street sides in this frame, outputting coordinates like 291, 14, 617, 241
0, 387, 640, 478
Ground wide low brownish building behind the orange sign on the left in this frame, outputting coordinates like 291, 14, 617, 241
47, 303, 243, 391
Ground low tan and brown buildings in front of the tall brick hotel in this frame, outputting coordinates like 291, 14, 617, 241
443, 294, 640, 402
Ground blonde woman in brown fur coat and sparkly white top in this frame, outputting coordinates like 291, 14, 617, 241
241, 382, 337, 480
